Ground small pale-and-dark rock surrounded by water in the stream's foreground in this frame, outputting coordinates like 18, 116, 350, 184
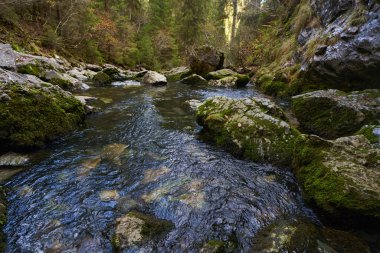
113, 211, 174, 252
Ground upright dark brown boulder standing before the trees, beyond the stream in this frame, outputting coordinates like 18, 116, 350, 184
190, 46, 224, 77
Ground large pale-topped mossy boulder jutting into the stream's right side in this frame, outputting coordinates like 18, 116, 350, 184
197, 97, 300, 165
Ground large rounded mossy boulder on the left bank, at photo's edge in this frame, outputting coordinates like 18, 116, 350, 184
0, 69, 85, 151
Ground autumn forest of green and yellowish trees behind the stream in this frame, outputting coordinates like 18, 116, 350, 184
0, 0, 289, 69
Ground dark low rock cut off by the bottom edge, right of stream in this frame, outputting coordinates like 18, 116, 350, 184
251, 218, 369, 253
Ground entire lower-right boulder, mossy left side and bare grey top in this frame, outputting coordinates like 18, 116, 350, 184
293, 135, 380, 219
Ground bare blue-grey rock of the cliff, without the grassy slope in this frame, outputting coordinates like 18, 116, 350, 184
298, 0, 380, 90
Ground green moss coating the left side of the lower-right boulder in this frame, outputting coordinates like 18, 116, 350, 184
293, 136, 380, 217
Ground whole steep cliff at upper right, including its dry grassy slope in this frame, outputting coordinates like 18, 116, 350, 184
254, 0, 380, 96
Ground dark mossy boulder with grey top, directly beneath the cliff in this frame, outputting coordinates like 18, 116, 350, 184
292, 90, 380, 139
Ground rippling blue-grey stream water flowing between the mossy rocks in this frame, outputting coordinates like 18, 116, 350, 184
5, 83, 312, 252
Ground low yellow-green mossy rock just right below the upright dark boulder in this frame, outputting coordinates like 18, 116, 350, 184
206, 69, 249, 87
